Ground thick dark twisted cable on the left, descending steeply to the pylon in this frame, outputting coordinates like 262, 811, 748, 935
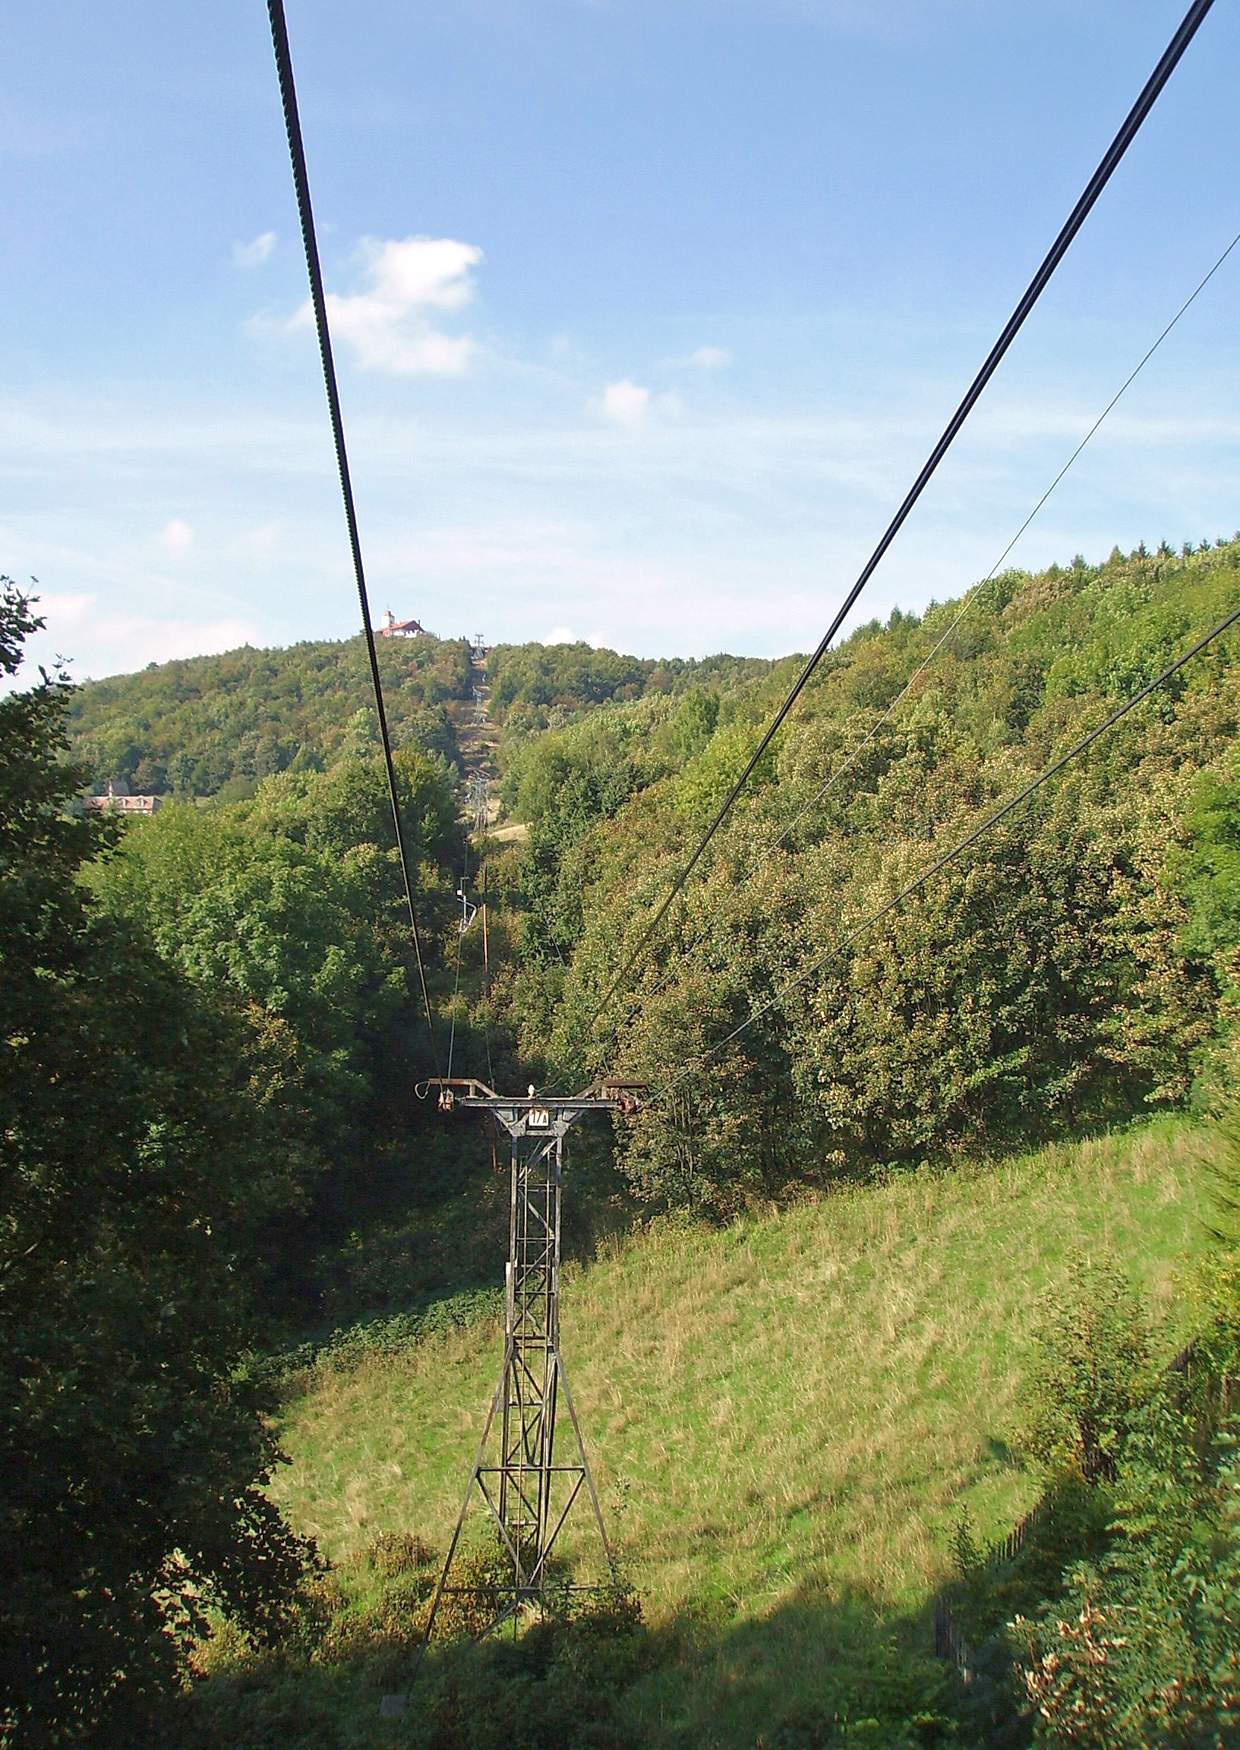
268, 0, 439, 1075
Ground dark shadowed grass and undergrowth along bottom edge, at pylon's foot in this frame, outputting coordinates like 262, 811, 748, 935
168, 1586, 978, 1750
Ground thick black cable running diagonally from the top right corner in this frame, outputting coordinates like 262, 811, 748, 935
591, 0, 1214, 1024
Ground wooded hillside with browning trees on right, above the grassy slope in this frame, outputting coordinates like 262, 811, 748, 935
507, 541, 1240, 1211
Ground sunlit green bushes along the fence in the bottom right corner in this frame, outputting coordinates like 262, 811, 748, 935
953, 1190, 1240, 1750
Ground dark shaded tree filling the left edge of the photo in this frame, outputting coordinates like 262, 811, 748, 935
0, 585, 304, 1743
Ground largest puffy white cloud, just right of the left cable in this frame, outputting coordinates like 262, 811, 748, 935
290, 236, 483, 376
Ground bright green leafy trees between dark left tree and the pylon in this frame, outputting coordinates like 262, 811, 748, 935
89, 747, 460, 1314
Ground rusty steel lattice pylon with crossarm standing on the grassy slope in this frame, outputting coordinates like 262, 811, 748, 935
423, 1078, 640, 1645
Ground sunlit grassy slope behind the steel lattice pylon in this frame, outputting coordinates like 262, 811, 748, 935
267, 1120, 1205, 1745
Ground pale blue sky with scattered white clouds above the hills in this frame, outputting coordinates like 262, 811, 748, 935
0, 0, 1240, 677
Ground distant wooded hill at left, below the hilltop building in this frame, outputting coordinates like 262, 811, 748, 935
70, 635, 472, 796
